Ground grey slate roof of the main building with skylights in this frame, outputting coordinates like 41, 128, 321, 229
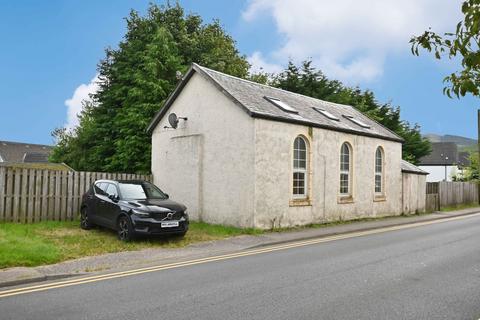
147, 64, 403, 142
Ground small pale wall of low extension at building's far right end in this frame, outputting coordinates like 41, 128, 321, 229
402, 172, 427, 214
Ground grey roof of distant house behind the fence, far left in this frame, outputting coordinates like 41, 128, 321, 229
0, 141, 53, 163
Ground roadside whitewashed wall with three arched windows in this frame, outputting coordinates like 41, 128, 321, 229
255, 119, 402, 228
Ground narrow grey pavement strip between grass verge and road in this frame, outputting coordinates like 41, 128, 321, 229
0, 208, 480, 287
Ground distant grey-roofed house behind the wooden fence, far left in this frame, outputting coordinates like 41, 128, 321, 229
0, 140, 71, 170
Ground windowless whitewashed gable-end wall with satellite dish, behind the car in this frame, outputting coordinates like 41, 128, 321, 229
152, 73, 255, 227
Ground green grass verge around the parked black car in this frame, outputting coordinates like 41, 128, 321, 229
0, 221, 262, 268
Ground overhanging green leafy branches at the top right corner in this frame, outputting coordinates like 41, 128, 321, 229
410, 0, 480, 97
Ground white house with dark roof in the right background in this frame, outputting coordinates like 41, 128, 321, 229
419, 142, 470, 182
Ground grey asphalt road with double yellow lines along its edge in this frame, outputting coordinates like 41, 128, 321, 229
0, 206, 480, 320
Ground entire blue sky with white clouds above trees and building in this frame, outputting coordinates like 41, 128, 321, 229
0, 0, 479, 144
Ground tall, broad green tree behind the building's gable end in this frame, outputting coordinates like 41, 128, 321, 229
51, 4, 249, 173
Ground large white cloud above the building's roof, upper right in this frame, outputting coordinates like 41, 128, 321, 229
243, 0, 461, 83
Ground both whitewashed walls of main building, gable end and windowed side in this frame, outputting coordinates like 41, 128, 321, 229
152, 74, 416, 228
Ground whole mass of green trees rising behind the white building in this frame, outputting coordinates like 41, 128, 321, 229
50, 4, 430, 173
